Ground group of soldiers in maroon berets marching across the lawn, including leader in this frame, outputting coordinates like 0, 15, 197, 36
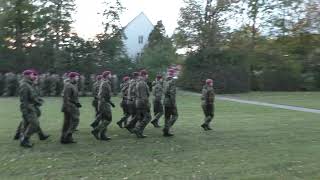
14, 69, 214, 148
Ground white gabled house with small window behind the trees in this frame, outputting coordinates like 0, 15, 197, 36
123, 12, 154, 59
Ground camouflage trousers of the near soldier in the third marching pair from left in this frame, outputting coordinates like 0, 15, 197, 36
94, 104, 112, 133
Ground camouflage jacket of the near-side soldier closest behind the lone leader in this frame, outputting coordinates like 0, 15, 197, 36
164, 79, 176, 107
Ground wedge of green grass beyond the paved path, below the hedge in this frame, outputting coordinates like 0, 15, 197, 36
226, 92, 320, 109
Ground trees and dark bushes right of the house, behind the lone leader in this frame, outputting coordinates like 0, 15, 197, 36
175, 0, 320, 93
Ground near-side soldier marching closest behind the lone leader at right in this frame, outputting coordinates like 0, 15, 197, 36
163, 70, 178, 137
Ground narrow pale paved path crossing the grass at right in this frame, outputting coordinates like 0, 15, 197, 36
216, 96, 320, 114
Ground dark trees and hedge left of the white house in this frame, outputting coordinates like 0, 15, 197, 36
0, 0, 134, 75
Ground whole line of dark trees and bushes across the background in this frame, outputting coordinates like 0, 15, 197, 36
0, 0, 320, 93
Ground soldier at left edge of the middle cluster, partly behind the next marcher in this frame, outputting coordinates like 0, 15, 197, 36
117, 76, 130, 128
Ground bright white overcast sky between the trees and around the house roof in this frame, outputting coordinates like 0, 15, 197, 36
73, 0, 183, 39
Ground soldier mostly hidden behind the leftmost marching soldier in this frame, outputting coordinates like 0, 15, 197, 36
14, 72, 50, 141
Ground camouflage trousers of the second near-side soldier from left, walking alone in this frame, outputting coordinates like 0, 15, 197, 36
61, 108, 80, 139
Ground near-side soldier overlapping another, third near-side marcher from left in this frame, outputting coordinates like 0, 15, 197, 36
91, 71, 114, 141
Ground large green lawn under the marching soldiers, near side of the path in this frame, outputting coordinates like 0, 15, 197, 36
0, 93, 320, 180
